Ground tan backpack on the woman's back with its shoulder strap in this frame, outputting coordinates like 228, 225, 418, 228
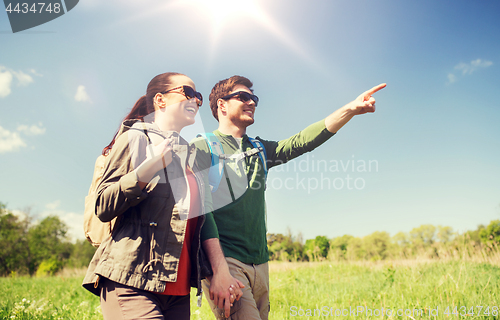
83, 124, 151, 247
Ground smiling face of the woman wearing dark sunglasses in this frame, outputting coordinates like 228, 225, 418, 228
154, 75, 199, 132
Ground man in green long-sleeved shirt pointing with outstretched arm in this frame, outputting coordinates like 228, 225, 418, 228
194, 76, 386, 320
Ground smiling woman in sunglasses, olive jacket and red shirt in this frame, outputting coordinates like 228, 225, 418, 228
83, 73, 241, 319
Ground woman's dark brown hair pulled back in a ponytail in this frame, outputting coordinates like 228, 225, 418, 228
102, 72, 184, 155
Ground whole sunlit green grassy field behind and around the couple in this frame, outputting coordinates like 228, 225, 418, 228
0, 260, 500, 320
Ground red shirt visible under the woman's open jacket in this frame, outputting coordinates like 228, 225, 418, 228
160, 168, 200, 296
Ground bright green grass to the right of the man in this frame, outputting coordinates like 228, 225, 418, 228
271, 261, 500, 319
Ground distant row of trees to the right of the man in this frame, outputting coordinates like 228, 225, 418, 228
267, 220, 500, 261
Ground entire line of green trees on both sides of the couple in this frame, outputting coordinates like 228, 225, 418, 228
0, 203, 500, 276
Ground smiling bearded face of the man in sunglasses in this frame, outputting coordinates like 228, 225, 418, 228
219, 84, 255, 128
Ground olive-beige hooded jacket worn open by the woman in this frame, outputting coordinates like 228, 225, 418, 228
83, 120, 215, 295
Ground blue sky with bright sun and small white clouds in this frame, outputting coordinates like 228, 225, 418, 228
0, 0, 500, 239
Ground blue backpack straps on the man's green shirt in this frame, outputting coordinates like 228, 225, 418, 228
197, 132, 267, 192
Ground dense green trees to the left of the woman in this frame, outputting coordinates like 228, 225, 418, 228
0, 203, 95, 276
